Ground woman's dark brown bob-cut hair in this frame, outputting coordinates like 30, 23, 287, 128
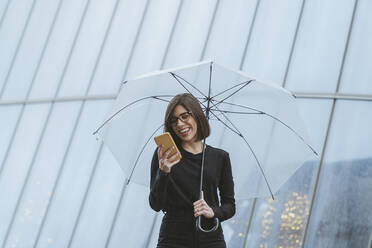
164, 93, 211, 144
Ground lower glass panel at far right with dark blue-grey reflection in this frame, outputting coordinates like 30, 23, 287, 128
305, 101, 372, 248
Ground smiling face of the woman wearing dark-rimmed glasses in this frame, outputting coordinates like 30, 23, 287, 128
171, 105, 198, 143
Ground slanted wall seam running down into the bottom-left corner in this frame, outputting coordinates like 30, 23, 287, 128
3, 0, 90, 247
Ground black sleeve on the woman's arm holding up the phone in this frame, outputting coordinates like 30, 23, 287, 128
149, 149, 169, 212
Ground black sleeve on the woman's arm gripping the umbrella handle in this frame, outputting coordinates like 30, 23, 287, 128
212, 153, 235, 221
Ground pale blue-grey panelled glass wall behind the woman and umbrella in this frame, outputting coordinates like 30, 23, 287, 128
0, 0, 372, 248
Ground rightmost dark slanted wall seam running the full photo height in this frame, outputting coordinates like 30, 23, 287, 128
302, 0, 358, 248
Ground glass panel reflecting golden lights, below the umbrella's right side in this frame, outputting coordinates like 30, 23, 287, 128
246, 160, 318, 247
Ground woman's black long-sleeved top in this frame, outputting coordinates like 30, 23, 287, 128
149, 145, 235, 221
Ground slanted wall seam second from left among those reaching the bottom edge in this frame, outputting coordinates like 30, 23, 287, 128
34, 0, 119, 247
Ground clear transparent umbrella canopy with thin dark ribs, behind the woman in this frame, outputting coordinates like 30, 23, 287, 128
95, 61, 316, 199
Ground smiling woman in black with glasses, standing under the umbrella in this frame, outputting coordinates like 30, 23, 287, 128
149, 94, 235, 248
